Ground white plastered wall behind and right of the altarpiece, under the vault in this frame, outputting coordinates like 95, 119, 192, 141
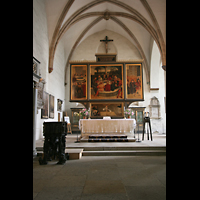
65, 30, 166, 133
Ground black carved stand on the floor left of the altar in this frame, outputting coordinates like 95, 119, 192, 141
39, 122, 67, 165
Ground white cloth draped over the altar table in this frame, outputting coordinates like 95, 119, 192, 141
79, 119, 136, 137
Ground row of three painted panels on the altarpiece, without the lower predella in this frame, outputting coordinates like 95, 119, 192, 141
70, 63, 144, 103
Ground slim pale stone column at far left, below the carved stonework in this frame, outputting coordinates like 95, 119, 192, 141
33, 82, 38, 156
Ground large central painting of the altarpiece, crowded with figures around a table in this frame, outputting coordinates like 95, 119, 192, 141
90, 64, 124, 100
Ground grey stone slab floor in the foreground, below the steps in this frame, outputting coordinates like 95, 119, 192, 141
33, 156, 166, 200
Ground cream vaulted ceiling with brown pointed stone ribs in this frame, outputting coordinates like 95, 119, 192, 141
45, 0, 166, 77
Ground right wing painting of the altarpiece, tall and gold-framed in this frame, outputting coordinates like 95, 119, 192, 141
126, 64, 144, 100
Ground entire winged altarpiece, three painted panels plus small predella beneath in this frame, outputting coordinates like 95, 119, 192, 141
70, 59, 144, 118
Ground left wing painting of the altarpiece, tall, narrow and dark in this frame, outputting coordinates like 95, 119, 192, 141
70, 65, 87, 101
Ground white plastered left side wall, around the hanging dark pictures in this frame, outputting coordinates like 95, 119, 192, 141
33, 0, 65, 140
